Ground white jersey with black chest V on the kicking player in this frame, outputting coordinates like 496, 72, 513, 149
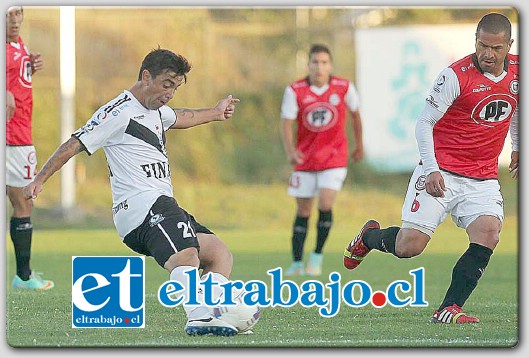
73, 91, 176, 240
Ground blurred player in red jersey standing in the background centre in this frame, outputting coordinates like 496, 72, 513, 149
281, 44, 364, 276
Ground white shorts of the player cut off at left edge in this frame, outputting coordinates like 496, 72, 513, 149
6, 145, 37, 188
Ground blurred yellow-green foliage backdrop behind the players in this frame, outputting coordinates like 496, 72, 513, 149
16, 6, 518, 227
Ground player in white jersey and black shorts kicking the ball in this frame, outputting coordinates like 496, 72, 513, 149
24, 49, 239, 336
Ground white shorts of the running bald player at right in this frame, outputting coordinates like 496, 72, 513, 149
402, 165, 504, 237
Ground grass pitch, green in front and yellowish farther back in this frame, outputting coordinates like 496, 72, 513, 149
6, 177, 520, 348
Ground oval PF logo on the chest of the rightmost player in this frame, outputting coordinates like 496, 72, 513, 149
471, 94, 517, 127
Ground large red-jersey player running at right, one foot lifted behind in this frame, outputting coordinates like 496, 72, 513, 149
344, 13, 519, 323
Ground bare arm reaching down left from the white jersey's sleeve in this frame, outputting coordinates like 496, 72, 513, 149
24, 137, 83, 199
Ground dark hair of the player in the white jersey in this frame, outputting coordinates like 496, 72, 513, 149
138, 48, 191, 82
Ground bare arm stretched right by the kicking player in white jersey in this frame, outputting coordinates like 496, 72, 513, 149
171, 95, 240, 129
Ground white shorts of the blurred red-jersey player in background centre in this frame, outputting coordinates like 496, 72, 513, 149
288, 168, 347, 198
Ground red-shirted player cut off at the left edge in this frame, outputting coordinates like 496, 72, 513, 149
6, 6, 54, 291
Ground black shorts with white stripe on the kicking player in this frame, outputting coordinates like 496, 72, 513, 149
123, 196, 213, 267
